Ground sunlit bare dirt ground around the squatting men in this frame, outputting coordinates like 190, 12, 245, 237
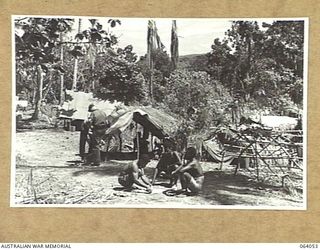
13, 129, 303, 208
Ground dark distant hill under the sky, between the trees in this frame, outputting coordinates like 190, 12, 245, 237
178, 54, 208, 71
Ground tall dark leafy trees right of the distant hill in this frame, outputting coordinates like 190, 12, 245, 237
208, 21, 304, 106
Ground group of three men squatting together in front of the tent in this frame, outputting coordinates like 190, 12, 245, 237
118, 139, 204, 195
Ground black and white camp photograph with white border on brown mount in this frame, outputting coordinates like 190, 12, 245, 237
10, 15, 309, 210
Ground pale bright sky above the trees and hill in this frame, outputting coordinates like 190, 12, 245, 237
75, 18, 231, 56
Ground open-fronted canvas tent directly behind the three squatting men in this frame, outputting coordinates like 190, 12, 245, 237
99, 106, 177, 160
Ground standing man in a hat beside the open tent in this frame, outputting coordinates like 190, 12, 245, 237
86, 104, 109, 166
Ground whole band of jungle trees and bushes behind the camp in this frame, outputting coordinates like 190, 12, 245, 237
15, 17, 304, 144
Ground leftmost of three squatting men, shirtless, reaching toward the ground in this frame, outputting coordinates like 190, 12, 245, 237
118, 154, 152, 193
